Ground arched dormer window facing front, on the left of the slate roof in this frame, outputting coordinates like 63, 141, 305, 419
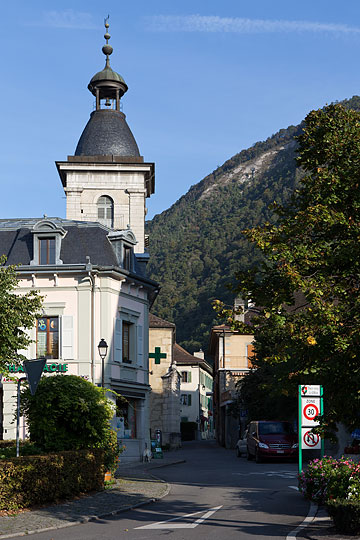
30, 219, 66, 266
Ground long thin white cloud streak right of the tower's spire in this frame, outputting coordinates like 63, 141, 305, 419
146, 15, 360, 36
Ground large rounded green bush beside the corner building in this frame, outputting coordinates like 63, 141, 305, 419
21, 375, 120, 470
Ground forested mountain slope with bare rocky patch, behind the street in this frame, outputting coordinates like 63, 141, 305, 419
146, 96, 360, 352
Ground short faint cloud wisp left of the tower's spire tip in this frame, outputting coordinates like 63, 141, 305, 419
27, 9, 98, 30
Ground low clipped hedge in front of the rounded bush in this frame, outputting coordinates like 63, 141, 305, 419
0, 449, 105, 510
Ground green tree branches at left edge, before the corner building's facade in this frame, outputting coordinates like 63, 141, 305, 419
0, 255, 42, 373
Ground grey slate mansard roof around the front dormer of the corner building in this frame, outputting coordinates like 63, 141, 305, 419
0, 218, 118, 266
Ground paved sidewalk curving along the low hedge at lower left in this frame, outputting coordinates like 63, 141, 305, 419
0, 456, 184, 539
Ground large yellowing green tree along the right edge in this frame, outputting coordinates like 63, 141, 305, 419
214, 105, 360, 429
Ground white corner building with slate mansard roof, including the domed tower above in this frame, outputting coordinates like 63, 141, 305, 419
0, 25, 158, 461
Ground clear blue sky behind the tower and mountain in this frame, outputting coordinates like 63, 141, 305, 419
0, 0, 360, 218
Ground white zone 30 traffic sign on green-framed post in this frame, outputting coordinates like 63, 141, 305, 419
298, 384, 324, 474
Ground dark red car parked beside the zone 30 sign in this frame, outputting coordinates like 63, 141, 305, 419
247, 420, 299, 463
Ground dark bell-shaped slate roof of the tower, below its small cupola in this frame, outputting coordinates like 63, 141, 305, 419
75, 109, 140, 157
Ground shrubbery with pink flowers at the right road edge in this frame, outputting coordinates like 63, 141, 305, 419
299, 457, 360, 534
